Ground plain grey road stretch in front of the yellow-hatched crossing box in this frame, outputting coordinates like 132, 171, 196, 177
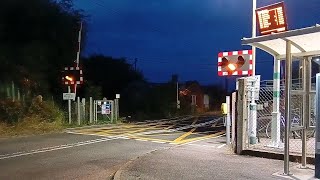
0, 134, 172, 179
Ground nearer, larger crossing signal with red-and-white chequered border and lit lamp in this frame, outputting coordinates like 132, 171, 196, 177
218, 50, 252, 76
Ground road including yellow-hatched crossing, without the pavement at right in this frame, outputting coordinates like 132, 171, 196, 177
0, 117, 224, 179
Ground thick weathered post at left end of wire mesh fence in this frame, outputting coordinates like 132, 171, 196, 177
236, 79, 248, 154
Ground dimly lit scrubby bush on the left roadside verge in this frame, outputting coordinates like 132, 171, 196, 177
0, 96, 64, 136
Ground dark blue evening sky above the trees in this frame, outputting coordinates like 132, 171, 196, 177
74, 0, 320, 84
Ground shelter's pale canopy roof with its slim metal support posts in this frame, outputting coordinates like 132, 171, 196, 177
241, 24, 320, 175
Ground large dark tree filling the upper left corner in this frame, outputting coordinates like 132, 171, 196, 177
0, 0, 85, 100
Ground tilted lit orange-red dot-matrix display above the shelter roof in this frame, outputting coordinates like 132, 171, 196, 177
256, 2, 288, 35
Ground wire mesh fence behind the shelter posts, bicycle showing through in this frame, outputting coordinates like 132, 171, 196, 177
247, 80, 315, 157
